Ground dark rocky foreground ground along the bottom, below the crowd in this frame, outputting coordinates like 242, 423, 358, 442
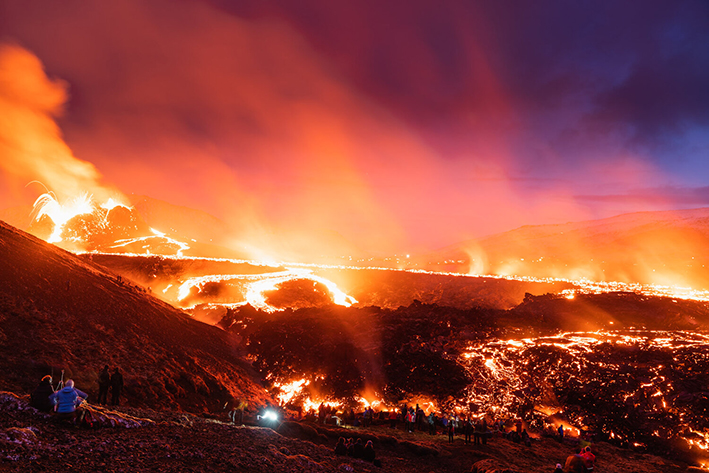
0, 392, 687, 473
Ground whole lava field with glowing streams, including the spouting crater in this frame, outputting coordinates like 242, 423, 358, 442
8, 186, 709, 466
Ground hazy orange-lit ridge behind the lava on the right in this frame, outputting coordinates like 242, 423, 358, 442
418, 208, 709, 289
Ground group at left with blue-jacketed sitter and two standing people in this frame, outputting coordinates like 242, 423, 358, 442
30, 365, 123, 425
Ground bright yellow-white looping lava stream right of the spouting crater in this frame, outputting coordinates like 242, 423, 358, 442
177, 268, 357, 312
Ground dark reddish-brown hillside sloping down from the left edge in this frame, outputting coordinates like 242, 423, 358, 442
0, 222, 268, 412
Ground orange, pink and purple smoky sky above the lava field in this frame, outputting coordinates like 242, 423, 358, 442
0, 0, 709, 252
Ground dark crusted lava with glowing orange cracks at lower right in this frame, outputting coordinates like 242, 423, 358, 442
458, 330, 709, 451
